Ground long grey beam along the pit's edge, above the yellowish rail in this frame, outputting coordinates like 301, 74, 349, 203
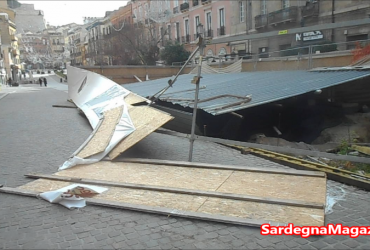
156, 130, 370, 164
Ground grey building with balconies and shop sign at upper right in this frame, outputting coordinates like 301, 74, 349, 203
229, 0, 370, 55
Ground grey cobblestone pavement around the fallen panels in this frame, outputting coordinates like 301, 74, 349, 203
0, 78, 370, 249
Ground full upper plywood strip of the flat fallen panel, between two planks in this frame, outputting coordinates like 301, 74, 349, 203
55, 161, 326, 204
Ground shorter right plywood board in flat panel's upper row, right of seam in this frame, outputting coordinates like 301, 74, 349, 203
217, 171, 326, 204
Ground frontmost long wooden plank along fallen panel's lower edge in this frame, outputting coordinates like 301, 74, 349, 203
0, 187, 286, 227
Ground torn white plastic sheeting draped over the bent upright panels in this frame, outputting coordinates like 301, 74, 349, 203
59, 67, 135, 170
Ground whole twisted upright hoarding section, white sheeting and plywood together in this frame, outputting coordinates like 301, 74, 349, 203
59, 67, 172, 170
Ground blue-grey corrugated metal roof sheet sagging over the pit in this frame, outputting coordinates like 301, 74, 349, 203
125, 70, 370, 115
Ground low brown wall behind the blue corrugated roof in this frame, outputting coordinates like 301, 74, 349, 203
82, 52, 352, 84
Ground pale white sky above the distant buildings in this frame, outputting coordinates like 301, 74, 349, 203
19, 0, 128, 26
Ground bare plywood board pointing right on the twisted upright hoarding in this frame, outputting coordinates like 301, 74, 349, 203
109, 106, 173, 159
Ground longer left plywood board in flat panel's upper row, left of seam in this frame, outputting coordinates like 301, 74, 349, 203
55, 161, 232, 191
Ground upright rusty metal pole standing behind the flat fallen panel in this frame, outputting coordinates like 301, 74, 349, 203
189, 23, 205, 162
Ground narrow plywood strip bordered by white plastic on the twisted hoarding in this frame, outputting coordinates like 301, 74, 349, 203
77, 106, 123, 158
